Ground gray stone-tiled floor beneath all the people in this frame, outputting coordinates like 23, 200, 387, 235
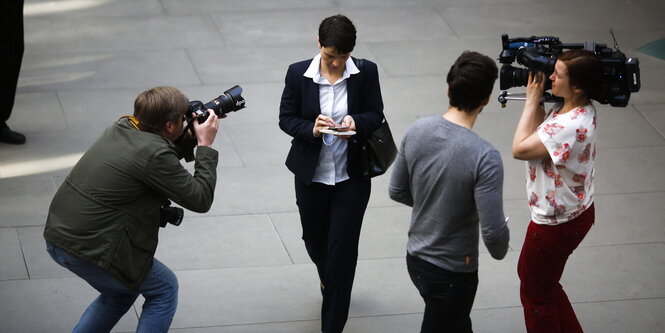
0, 0, 665, 333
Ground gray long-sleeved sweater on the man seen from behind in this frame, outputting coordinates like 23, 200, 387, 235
389, 116, 510, 272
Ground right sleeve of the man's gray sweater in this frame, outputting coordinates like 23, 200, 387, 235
474, 150, 510, 260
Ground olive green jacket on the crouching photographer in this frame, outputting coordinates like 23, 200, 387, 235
44, 119, 218, 290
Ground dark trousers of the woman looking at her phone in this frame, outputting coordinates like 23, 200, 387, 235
295, 179, 371, 333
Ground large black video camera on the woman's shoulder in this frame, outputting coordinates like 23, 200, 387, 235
499, 30, 640, 107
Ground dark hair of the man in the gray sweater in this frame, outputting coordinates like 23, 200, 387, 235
446, 51, 499, 112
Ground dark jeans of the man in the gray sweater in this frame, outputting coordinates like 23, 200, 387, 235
406, 254, 478, 333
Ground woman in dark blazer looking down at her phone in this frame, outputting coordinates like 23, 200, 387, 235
279, 15, 383, 332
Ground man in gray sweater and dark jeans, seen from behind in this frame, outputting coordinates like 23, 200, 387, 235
389, 51, 510, 333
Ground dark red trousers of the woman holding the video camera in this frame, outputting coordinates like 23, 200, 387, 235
517, 205, 595, 333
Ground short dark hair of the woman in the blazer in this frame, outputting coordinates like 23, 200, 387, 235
319, 14, 356, 54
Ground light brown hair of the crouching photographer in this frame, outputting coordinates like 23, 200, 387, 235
134, 87, 189, 131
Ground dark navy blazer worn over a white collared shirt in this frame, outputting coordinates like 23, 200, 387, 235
279, 58, 383, 185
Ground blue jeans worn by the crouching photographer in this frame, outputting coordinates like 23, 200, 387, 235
46, 242, 178, 333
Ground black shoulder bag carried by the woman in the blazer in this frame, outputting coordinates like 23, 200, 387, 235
357, 59, 397, 178
